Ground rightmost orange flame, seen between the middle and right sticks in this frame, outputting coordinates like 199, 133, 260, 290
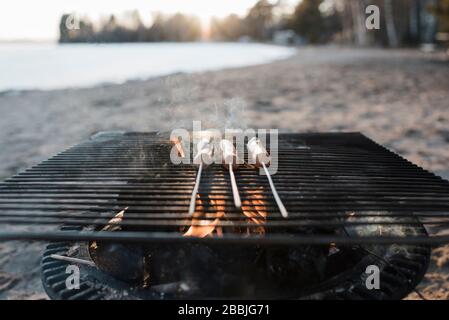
242, 187, 267, 234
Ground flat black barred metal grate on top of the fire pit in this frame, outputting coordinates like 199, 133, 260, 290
0, 133, 449, 245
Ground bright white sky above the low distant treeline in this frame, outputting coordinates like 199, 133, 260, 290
0, 0, 266, 41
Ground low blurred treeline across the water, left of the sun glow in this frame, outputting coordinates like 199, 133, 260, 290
59, 11, 202, 43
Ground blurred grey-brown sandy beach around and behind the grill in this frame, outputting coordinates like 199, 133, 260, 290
0, 47, 449, 299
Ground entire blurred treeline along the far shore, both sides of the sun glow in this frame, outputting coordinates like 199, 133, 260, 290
60, 0, 449, 47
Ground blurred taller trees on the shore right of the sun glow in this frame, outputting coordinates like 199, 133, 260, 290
211, 0, 449, 47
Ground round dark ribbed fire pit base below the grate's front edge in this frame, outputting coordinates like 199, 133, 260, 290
42, 227, 430, 300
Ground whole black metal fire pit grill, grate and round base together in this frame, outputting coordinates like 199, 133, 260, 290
0, 132, 449, 299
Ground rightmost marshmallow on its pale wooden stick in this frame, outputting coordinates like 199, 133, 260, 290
247, 137, 288, 218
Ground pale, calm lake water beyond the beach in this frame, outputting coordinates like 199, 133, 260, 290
0, 43, 295, 91
